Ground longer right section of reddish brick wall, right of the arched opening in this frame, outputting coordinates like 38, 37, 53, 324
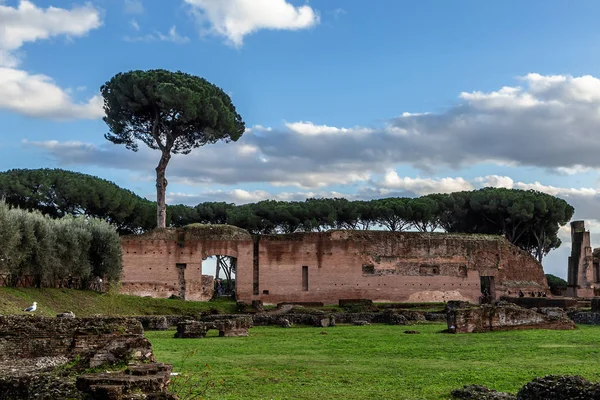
251, 231, 548, 304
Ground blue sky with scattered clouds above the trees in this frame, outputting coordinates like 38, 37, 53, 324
0, 0, 600, 278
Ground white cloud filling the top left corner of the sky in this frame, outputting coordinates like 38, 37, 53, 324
0, 0, 102, 68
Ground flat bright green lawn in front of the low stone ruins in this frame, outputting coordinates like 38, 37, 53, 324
146, 324, 600, 399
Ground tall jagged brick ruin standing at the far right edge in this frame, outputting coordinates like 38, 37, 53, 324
567, 221, 600, 297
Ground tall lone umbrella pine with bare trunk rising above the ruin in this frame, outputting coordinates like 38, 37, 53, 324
100, 69, 245, 228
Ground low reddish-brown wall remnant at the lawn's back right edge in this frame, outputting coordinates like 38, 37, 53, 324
447, 304, 575, 333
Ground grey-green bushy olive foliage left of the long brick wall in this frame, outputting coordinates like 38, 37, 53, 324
0, 201, 122, 287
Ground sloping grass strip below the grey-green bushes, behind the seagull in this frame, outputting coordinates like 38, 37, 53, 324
0, 287, 237, 317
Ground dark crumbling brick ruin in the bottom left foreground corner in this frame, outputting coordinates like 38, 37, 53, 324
0, 315, 172, 400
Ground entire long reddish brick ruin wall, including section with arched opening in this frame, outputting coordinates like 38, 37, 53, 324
122, 225, 549, 304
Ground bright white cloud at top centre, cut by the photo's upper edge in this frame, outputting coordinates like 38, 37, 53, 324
184, 0, 319, 47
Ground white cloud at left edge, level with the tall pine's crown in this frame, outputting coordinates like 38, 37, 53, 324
0, 67, 104, 120
